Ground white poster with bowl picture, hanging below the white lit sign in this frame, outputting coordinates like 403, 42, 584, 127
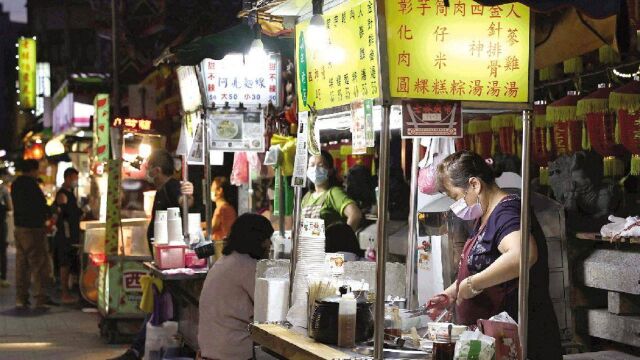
207, 111, 265, 152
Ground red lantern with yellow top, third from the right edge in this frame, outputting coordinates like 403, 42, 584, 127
547, 91, 588, 155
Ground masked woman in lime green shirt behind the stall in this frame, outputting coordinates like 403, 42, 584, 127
302, 151, 362, 230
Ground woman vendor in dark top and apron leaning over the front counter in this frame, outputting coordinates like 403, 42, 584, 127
427, 151, 562, 360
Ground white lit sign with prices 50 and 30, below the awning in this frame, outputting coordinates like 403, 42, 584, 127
200, 54, 281, 107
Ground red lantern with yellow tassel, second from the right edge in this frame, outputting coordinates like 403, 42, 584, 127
576, 84, 624, 177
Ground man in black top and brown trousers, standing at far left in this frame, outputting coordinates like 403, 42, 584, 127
11, 160, 49, 309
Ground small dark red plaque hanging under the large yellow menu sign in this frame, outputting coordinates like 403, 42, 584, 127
402, 101, 462, 138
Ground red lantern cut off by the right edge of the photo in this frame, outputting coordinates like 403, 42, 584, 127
609, 80, 640, 176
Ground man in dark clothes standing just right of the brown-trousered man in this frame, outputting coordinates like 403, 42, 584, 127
54, 168, 82, 304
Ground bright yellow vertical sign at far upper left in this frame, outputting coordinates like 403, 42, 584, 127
18, 37, 36, 109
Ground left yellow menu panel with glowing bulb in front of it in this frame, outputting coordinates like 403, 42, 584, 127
296, 0, 380, 111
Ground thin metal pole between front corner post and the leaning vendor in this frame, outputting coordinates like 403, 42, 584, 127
406, 138, 420, 309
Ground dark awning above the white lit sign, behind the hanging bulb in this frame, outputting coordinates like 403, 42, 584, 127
172, 24, 294, 65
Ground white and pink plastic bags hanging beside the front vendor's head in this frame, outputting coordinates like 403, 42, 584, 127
418, 137, 456, 195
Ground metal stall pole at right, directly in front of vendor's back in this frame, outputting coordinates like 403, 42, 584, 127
518, 110, 531, 359
